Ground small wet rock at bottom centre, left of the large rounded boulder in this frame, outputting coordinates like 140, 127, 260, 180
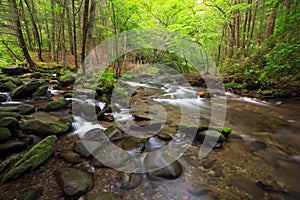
117, 172, 143, 190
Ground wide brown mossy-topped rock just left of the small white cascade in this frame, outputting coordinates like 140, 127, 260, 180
20, 112, 71, 138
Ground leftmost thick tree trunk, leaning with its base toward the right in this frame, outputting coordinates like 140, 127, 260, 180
9, 0, 35, 70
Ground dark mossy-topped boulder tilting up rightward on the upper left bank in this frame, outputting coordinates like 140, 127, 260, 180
10, 81, 43, 99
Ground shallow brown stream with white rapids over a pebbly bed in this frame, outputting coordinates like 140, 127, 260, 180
1, 77, 300, 200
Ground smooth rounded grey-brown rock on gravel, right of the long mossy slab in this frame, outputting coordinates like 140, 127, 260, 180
54, 167, 94, 196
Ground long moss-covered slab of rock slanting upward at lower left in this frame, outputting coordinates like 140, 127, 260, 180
2, 135, 57, 181
